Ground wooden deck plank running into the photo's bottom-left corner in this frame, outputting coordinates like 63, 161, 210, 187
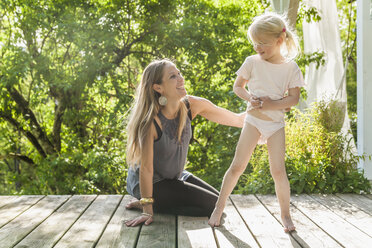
0, 196, 70, 248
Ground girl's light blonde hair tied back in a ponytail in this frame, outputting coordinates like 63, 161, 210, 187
248, 13, 299, 60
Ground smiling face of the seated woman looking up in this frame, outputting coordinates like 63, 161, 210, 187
158, 63, 187, 99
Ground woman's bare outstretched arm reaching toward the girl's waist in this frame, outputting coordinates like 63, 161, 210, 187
188, 96, 246, 127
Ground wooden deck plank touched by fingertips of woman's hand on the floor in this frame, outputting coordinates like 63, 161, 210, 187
96, 195, 141, 248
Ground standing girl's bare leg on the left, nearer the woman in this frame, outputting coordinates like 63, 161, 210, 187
208, 122, 261, 227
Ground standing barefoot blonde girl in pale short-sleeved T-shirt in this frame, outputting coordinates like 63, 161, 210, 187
209, 13, 304, 232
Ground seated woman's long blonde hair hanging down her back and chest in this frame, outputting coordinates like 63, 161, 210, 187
127, 59, 187, 166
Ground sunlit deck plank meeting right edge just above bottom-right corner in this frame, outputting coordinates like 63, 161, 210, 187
311, 195, 372, 238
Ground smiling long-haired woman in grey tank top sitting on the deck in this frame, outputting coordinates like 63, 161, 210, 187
126, 59, 258, 226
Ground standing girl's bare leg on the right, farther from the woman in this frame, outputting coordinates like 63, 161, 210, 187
267, 128, 295, 232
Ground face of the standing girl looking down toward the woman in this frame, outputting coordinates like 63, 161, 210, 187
253, 35, 282, 63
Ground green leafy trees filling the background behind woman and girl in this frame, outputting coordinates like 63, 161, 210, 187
0, 0, 368, 194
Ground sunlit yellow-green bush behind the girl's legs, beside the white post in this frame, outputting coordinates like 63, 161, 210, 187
235, 101, 371, 194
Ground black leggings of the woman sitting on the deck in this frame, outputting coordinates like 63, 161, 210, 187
153, 175, 219, 217
